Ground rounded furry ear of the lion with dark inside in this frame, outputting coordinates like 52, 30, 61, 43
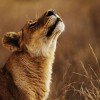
3, 32, 21, 51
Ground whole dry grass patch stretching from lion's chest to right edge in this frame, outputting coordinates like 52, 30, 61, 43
49, 44, 100, 100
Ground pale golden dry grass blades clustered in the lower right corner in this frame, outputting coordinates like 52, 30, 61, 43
71, 44, 100, 100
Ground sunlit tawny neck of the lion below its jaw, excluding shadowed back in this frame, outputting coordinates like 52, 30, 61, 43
6, 53, 54, 100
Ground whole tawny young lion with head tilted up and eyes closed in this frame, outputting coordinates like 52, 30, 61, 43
0, 10, 64, 100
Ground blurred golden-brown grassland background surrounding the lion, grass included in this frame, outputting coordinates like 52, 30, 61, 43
0, 0, 100, 100
